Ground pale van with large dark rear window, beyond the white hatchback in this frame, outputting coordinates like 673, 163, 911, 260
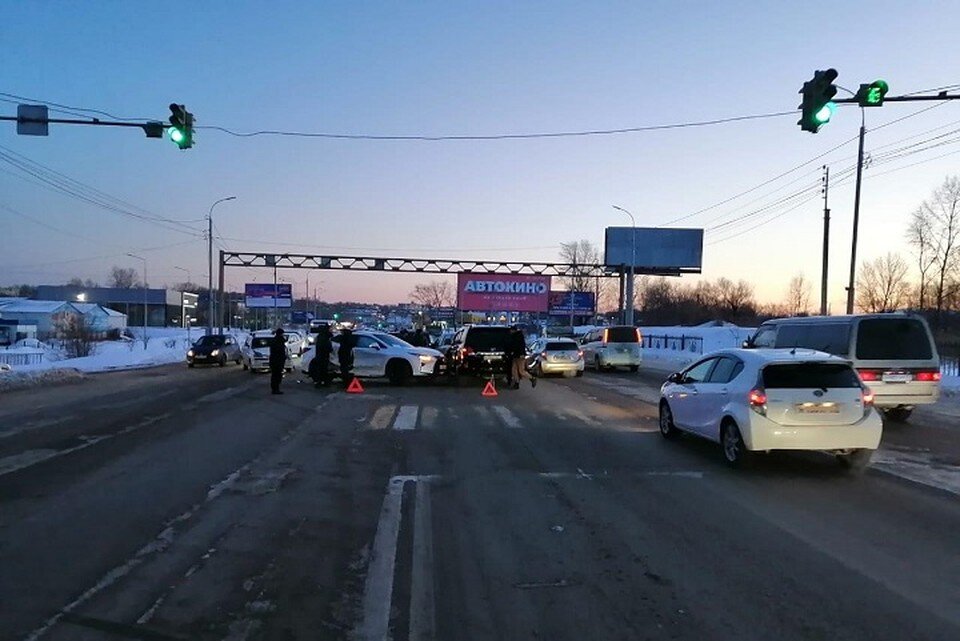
744, 313, 940, 421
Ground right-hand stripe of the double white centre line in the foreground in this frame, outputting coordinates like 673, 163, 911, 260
409, 483, 436, 641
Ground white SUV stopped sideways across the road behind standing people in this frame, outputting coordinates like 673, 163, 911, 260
300, 331, 443, 385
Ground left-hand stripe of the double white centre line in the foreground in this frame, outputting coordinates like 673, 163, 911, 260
358, 478, 404, 641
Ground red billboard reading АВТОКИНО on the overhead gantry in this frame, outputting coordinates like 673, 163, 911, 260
457, 274, 550, 312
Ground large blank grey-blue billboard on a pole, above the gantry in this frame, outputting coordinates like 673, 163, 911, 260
603, 227, 703, 274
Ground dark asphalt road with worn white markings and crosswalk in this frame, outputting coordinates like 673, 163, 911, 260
0, 366, 960, 641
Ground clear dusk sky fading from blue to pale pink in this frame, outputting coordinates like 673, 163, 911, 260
0, 0, 960, 310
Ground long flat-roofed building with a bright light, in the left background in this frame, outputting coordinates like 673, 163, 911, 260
36, 285, 195, 327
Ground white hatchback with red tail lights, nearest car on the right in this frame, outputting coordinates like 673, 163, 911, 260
660, 349, 883, 470
